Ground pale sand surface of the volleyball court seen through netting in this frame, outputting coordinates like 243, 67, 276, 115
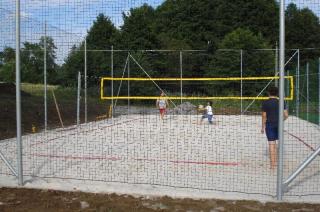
0, 110, 320, 195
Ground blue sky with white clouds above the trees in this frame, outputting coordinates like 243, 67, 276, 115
0, 0, 320, 63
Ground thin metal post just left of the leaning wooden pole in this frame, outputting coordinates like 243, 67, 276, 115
43, 21, 48, 133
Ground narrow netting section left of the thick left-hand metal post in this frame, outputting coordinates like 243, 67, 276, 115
0, 1, 17, 175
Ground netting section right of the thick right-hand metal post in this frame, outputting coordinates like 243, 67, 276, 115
283, 0, 320, 199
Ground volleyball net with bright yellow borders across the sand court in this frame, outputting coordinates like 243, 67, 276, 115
100, 76, 294, 100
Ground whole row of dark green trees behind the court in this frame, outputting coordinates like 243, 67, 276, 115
0, 0, 320, 94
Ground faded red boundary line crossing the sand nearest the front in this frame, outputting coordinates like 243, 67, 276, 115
31, 154, 241, 166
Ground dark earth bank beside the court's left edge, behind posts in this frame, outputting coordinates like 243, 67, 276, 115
0, 88, 107, 140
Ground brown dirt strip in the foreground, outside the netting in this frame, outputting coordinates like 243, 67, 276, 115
0, 188, 320, 212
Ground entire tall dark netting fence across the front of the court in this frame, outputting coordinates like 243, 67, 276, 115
0, 0, 320, 198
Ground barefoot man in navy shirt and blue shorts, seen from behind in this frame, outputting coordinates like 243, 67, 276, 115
261, 87, 288, 169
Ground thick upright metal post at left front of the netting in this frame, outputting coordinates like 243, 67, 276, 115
16, 0, 23, 186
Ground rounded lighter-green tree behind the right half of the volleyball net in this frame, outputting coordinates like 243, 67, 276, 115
206, 28, 274, 94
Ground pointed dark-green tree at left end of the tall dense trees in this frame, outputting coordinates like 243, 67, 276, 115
59, 14, 119, 86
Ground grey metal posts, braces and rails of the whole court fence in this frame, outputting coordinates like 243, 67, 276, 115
7, 0, 320, 201
